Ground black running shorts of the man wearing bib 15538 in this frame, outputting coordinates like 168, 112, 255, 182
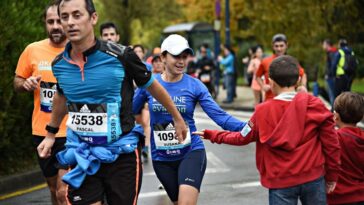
68, 146, 143, 205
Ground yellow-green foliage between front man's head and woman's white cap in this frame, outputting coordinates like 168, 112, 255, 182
99, 0, 183, 48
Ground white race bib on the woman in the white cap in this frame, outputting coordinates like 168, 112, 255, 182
153, 122, 191, 154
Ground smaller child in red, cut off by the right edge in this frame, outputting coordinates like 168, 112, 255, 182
327, 92, 364, 205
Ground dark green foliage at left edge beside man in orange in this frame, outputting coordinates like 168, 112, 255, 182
0, 0, 48, 175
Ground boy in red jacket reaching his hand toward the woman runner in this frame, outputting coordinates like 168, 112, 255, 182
196, 55, 340, 205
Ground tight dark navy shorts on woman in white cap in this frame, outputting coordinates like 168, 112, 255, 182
153, 149, 207, 202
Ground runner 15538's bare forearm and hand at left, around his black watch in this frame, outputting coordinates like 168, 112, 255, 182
37, 92, 67, 158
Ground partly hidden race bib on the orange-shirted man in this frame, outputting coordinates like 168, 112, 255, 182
40, 81, 57, 112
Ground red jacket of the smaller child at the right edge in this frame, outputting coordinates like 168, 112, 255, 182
327, 127, 364, 204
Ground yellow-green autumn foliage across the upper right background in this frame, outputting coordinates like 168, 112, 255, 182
178, 0, 364, 76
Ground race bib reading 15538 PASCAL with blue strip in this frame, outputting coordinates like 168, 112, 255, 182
67, 103, 122, 144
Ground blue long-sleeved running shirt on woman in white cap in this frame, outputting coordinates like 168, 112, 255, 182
133, 74, 245, 161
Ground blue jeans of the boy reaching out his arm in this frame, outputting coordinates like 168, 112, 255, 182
269, 177, 326, 205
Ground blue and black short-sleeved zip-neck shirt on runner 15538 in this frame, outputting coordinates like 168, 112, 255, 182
52, 40, 154, 144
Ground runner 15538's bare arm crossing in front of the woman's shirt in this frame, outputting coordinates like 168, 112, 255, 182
147, 80, 187, 143
